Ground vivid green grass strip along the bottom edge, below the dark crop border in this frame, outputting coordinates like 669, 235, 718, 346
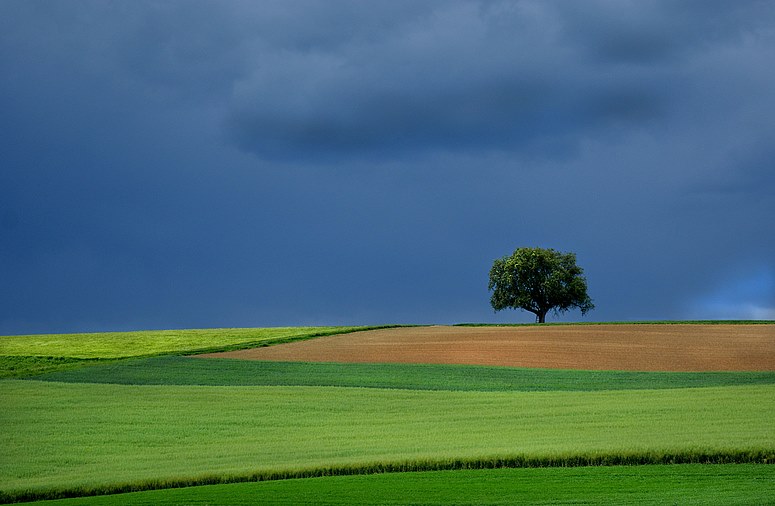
28, 464, 775, 506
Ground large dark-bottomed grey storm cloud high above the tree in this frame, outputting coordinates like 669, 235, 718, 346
224, 2, 667, 157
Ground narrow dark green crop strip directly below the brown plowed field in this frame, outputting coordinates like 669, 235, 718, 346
37, 357, 775, 392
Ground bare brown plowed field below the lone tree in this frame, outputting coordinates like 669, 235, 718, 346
200, 324, 775, 371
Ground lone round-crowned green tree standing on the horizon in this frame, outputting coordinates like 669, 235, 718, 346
489, 248, 595, 323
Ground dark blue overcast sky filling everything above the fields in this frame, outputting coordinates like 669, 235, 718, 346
0, 0, 775, 334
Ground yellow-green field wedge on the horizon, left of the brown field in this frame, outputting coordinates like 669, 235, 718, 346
0, 327, 388, 358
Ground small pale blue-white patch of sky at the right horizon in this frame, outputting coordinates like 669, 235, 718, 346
689, 268, 775, 320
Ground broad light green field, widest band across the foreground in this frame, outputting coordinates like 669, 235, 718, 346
0, 380, 775, 497
